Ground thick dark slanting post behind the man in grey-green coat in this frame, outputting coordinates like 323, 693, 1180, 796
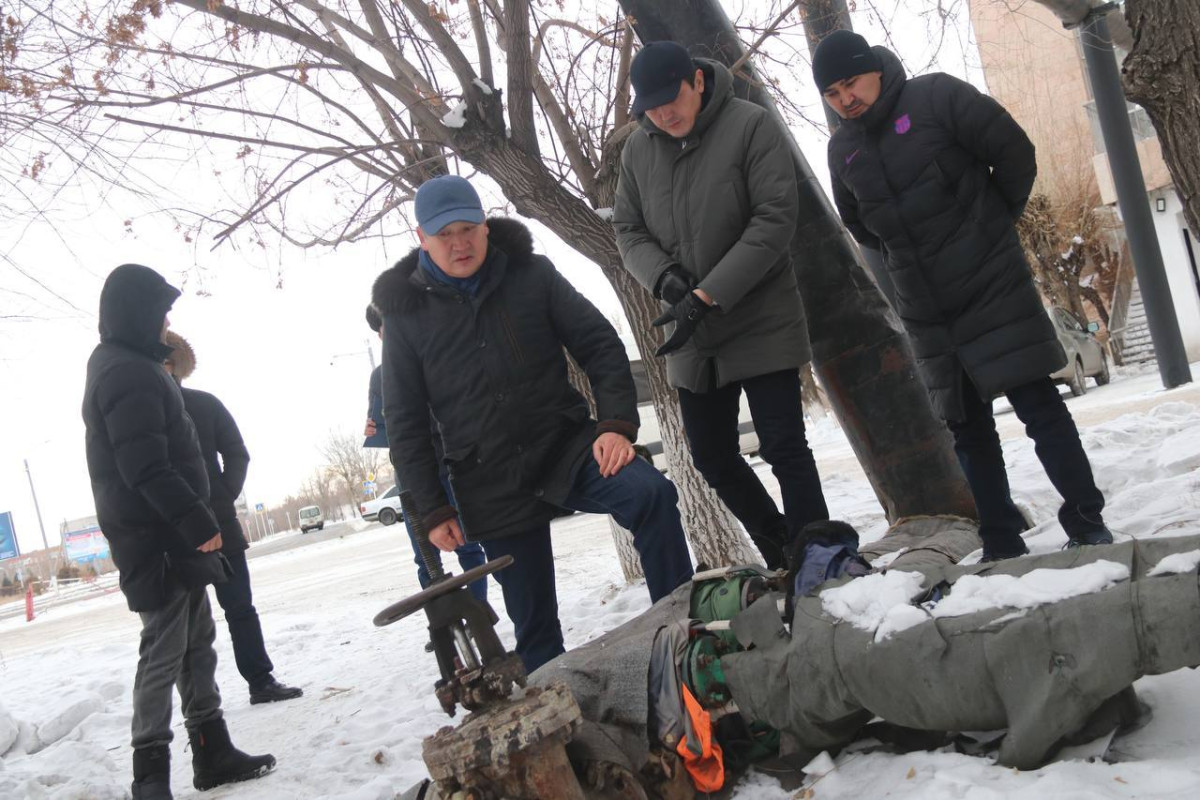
620, 0, 976, 522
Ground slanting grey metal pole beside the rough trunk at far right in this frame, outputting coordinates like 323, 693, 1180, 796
1080, 2, 1192, 389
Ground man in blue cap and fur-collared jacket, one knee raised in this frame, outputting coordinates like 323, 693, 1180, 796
372, 175, 692, 672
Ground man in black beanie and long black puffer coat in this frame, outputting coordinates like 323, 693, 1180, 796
812, 30, 1112, 560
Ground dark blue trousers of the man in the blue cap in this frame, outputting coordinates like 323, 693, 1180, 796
484, 456, 692, 673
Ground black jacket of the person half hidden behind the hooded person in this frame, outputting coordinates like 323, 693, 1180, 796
182, 386, 250, 552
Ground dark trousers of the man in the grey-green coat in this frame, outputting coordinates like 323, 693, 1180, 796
679, 369, 829, 569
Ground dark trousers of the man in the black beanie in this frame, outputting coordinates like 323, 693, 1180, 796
947, 373, 1104, 555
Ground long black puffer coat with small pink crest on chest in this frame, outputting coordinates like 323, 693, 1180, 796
829, 47, 1067, 420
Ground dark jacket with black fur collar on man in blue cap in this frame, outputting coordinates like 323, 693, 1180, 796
372, 219, 638, 541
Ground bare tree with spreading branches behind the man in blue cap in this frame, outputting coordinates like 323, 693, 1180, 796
0, 0, 752, 564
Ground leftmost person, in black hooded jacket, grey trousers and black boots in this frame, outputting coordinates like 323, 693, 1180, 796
83, 264, 275, 800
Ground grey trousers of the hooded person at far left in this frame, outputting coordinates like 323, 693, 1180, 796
132, 581, 221, 750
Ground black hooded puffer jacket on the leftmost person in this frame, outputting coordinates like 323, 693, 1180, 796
83, 264, 226, 612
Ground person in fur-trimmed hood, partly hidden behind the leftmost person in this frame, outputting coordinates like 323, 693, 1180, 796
163, 331, 304, 705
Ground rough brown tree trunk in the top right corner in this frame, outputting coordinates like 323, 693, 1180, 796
1123, 0, 1200, 236
